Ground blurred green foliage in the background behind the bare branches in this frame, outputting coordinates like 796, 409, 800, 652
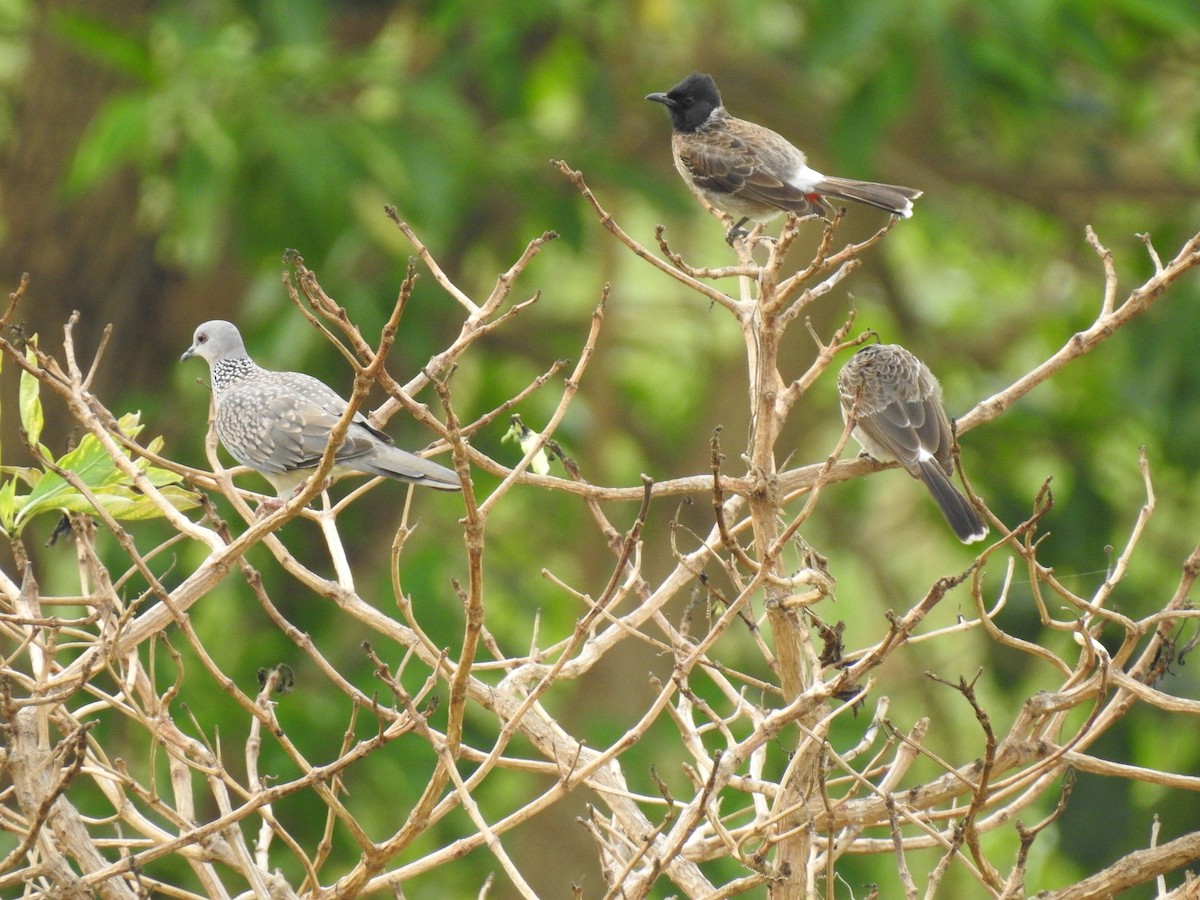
0, 0, 1200, 895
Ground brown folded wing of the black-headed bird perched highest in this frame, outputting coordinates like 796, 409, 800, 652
674, 116, 828, 215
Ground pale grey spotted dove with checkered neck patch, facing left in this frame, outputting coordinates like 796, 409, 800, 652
180, 319, 462, 499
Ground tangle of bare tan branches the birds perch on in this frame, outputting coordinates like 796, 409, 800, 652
0, 170, 1200, 900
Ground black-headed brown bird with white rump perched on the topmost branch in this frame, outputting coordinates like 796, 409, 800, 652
646, 72, 922, 241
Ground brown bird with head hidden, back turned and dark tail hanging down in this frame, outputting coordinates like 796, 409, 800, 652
838, 343, 988, 544
